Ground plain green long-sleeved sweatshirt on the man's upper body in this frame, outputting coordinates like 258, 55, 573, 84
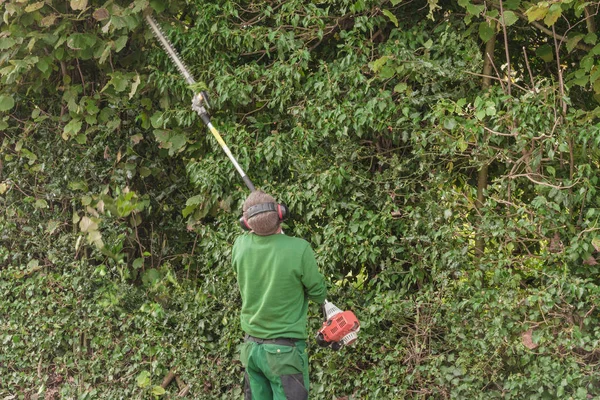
231, 233, 327, 339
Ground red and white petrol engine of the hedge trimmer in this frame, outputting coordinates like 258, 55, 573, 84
317, 300, 360, 351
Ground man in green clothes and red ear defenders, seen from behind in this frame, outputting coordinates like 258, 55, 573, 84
232, 191, 327, 400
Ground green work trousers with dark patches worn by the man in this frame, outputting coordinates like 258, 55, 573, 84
240, 340, 308, 400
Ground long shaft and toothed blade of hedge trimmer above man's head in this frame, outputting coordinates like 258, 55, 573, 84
146, 14, 256, 192
